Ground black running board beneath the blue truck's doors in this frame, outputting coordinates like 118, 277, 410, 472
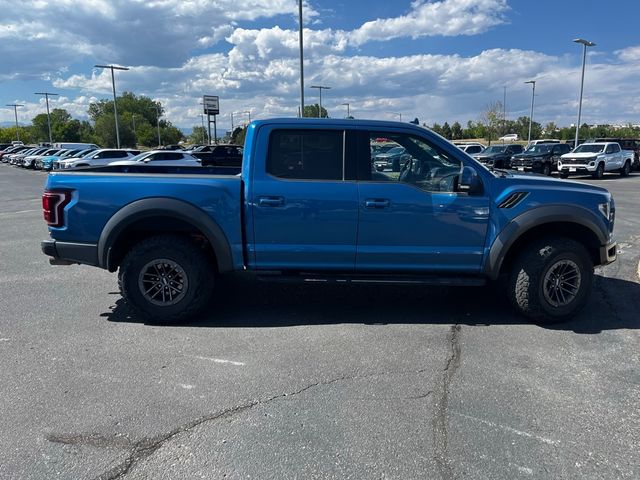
256, 272, 487, 287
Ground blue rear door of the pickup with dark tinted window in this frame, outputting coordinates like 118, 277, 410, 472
248, 124, 358, 272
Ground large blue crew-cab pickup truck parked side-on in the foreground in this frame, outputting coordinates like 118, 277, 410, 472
42, 119, 616, 322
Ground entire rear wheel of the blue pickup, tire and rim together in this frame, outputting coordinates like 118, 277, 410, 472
118, 235, 214, 323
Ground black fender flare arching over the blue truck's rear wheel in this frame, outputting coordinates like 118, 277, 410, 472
98, 198, 233, 273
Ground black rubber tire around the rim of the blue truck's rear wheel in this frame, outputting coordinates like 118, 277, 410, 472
118, 235, 215, 324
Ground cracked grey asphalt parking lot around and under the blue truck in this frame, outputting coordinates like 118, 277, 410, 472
0, 164, 640, 480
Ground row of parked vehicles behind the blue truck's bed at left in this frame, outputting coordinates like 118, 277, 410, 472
0, 144, 242, 171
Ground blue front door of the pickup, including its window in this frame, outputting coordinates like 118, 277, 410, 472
356, 131, 489, 273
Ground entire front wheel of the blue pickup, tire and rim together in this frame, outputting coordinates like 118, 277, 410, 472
509, 237, 593, 323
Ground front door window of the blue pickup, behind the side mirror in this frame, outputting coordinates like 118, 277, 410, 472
369, 132, 461, 192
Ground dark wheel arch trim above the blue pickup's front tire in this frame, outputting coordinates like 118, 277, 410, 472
484, 205, 609, 280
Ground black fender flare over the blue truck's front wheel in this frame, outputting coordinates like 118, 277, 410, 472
484, 205, 609, 280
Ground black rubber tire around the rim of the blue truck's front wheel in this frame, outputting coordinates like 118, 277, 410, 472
508, 237, 593, 323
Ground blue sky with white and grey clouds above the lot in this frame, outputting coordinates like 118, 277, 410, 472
0, 0, 640, 130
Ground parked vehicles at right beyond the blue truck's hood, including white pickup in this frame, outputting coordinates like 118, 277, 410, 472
456, 138, 640, 178
